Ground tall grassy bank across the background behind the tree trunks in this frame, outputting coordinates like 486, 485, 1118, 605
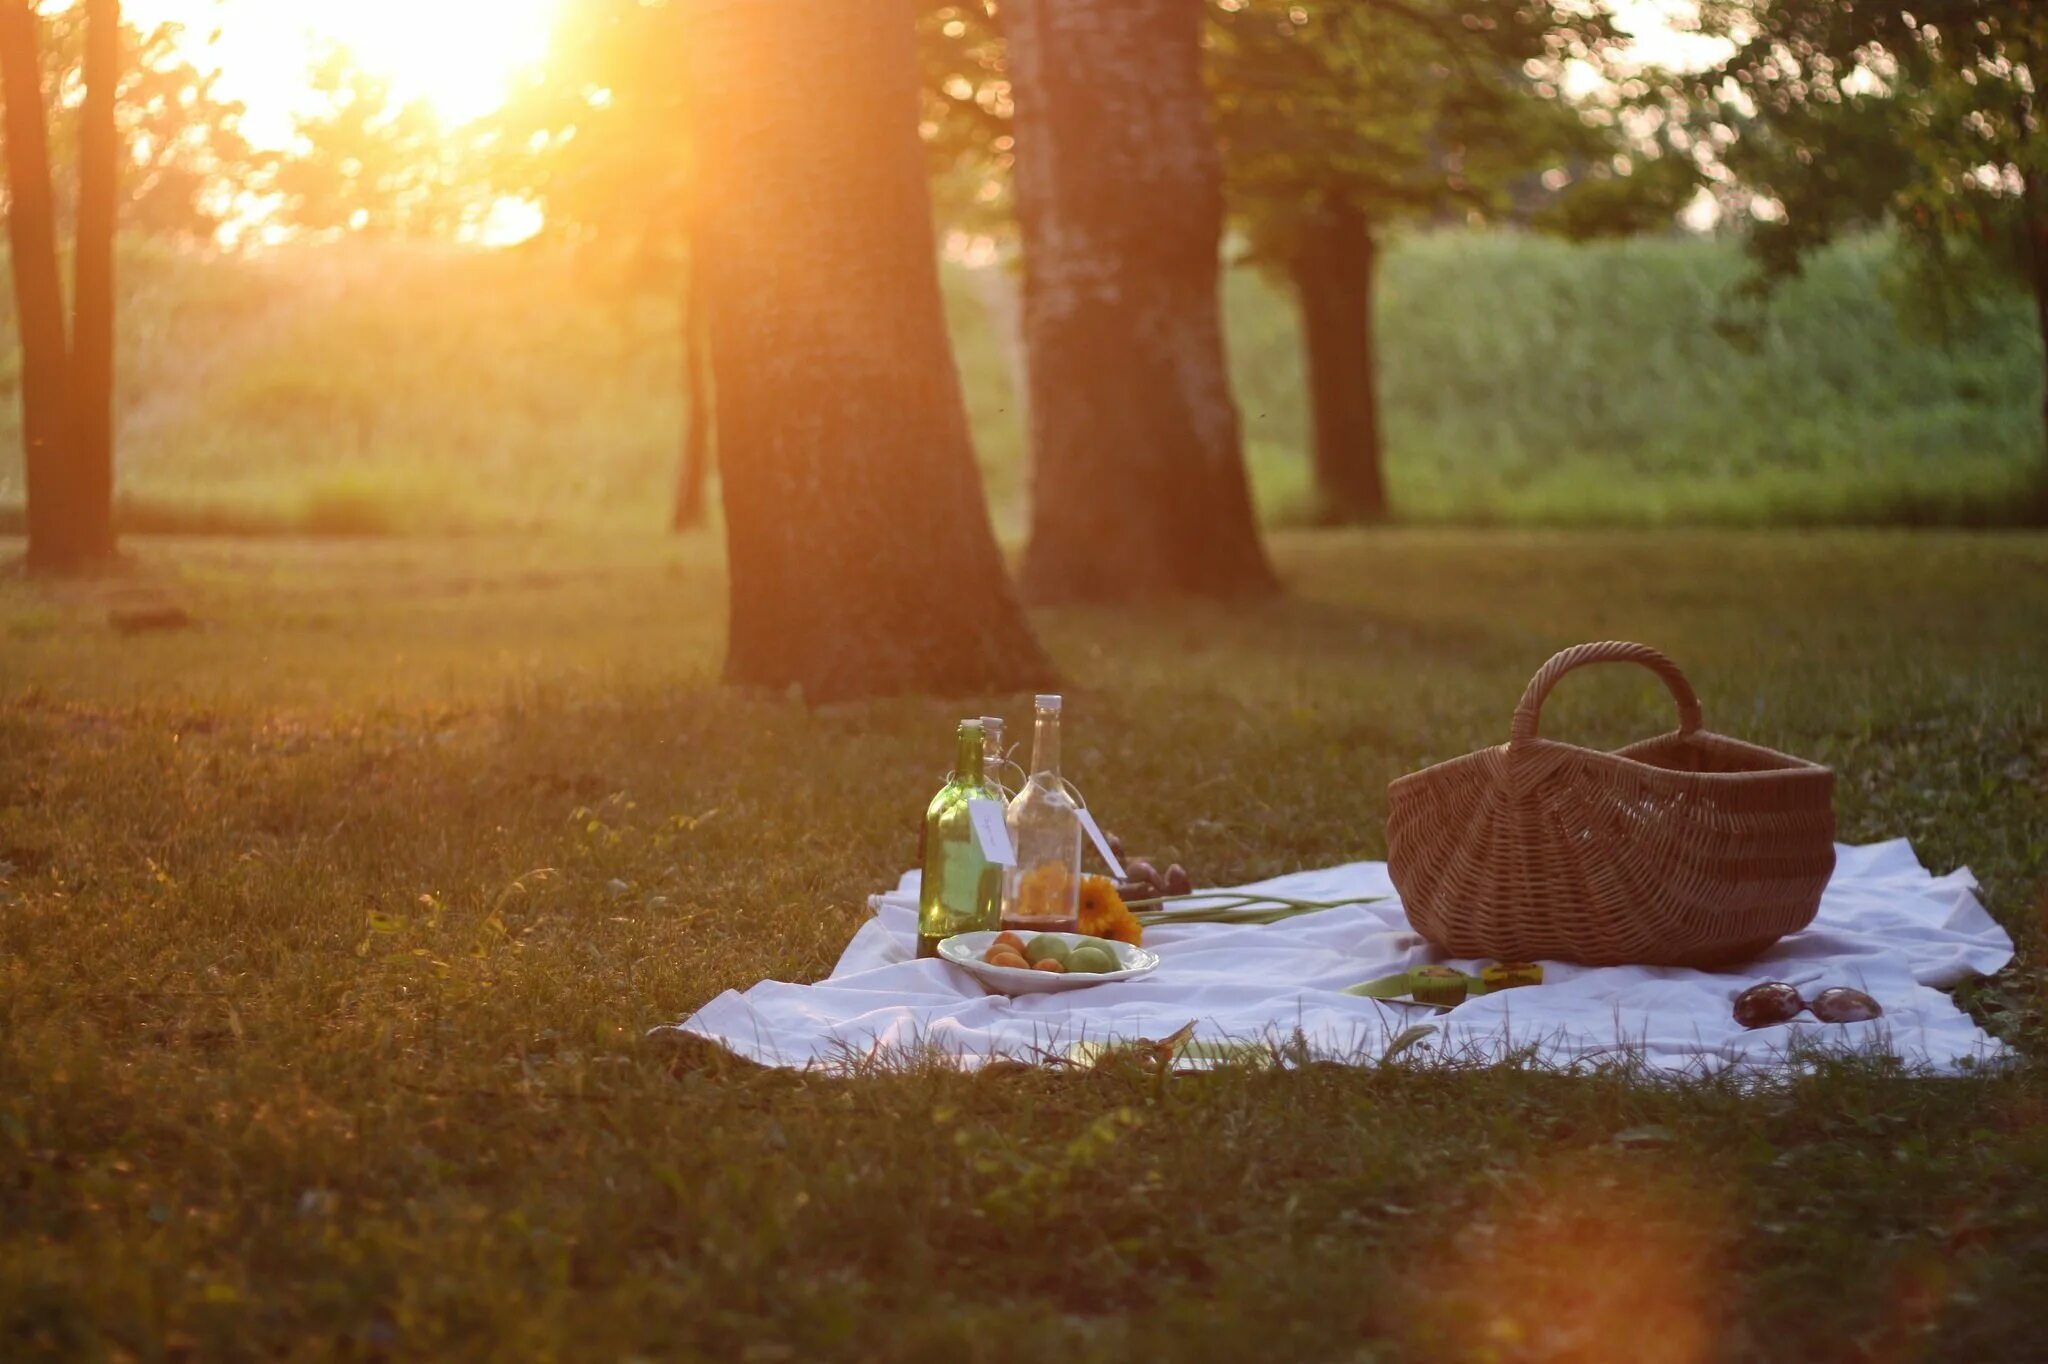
0, 231, 2042, 532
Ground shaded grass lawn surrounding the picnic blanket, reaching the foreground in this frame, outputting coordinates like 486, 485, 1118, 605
0, 530, 2048, 1364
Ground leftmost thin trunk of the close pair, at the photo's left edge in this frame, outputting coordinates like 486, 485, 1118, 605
0, 0, 78, 569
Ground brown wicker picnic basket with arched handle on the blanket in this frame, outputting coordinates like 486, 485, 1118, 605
1386, 641, 1835, 967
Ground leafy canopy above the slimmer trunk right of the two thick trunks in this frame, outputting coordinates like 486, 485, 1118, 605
1208, 0, 1696, 256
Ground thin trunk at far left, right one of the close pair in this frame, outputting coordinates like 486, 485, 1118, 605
70, 0, 121, 559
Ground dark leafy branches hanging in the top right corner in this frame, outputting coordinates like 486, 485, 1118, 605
1702, 0, 2048, 337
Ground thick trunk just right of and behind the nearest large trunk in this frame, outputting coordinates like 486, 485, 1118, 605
1006, 0, 1276, 600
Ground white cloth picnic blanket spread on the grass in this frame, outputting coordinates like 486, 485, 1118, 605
659, 840, 2013, 1073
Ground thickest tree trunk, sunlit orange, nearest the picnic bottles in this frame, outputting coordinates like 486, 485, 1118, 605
686, 0, 1051, 702
